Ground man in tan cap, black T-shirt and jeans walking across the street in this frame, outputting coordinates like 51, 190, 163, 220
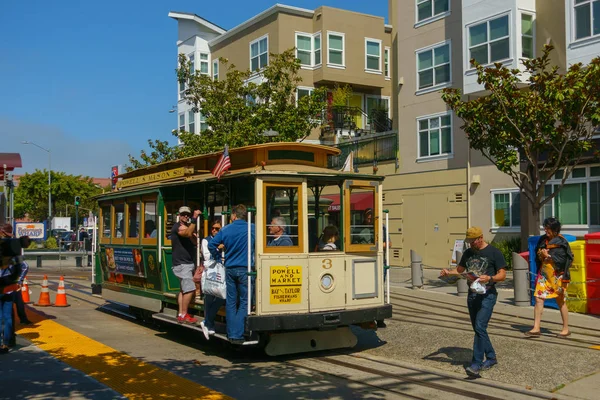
440, 226, 506, 376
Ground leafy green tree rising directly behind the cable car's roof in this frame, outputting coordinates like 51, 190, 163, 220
129, 49, 326, 168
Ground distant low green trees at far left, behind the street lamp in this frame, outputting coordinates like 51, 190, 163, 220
15, 170, 102, 221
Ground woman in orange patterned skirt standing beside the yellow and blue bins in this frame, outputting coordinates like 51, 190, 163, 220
525, 218, 574, 338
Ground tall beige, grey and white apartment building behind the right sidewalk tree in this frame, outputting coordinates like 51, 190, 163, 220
382, 0, 600, 266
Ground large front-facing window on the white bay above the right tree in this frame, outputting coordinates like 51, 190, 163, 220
469, 15, 510, 64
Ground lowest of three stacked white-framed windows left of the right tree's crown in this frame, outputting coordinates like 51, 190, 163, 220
417, 113, 452, 158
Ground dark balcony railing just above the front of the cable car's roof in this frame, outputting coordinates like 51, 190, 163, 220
327, 132, 398, 169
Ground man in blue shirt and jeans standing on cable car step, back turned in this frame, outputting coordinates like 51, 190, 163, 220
208, 204, 255, 344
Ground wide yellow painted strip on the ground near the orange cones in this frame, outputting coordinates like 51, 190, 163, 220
16, 310, 231, 400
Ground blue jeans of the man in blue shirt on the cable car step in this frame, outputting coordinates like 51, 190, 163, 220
225, 267, 248, 339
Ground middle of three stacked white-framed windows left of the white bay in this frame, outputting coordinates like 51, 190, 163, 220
417, 43, 450, 89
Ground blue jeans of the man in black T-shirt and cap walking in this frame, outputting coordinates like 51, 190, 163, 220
467, 291, 498, 364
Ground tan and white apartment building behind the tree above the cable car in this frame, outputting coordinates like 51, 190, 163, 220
169, 4, 392, 143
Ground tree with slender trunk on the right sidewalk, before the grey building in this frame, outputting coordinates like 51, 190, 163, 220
442, 45, 600, 241
